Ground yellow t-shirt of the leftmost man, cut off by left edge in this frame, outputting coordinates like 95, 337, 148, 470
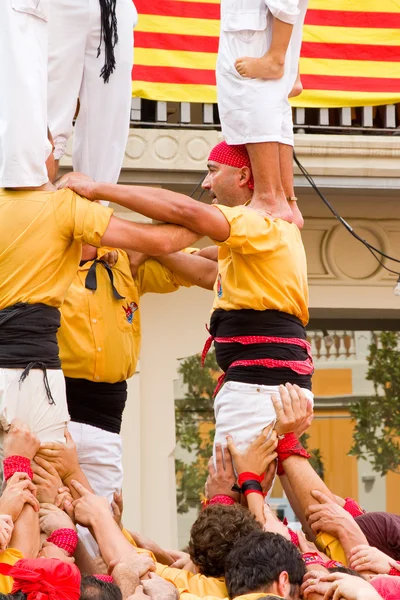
0, 189, 112, 310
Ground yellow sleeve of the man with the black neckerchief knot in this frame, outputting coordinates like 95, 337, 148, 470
135, 259, 192, 296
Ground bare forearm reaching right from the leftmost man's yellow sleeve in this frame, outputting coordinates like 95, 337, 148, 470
101, 213, 203, 256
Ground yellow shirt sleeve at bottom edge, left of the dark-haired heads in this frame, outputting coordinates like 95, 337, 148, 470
156, 563, 228, 598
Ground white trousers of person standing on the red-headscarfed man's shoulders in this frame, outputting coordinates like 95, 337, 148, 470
216, 0, 308, 146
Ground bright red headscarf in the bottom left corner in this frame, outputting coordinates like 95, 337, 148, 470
0, 558, 81, 600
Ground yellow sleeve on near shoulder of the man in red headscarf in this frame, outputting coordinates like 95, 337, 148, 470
214, 204, 281, 254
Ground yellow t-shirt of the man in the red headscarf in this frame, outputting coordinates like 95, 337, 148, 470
213, 204, 308, 325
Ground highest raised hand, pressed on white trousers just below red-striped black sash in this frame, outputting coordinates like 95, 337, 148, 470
272, 383, 313, 435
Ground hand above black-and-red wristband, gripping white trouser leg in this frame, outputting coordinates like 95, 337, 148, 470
227, 423, 278, 475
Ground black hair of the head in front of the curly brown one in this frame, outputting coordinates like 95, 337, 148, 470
225, 531, 306, 598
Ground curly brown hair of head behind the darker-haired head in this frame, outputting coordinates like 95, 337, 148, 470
189, 504, 261, 577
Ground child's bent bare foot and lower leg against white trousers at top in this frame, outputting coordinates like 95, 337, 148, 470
235, 17, 293, 79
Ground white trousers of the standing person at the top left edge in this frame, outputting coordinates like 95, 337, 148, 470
0, 0, 51, 188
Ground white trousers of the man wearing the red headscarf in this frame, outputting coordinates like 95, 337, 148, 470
214, 381, 314, 455
